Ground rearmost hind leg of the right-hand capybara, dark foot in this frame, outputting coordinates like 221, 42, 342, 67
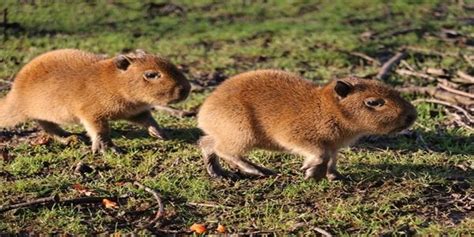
199, 136, 235, 178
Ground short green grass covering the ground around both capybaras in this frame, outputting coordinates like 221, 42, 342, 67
0, 0, 474, 236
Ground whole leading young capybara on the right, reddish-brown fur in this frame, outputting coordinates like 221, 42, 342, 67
198, 70, 416, 179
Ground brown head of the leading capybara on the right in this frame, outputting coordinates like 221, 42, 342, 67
324, 78, 417, 135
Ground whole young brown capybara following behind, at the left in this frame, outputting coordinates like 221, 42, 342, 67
0, 49, 190, 152
